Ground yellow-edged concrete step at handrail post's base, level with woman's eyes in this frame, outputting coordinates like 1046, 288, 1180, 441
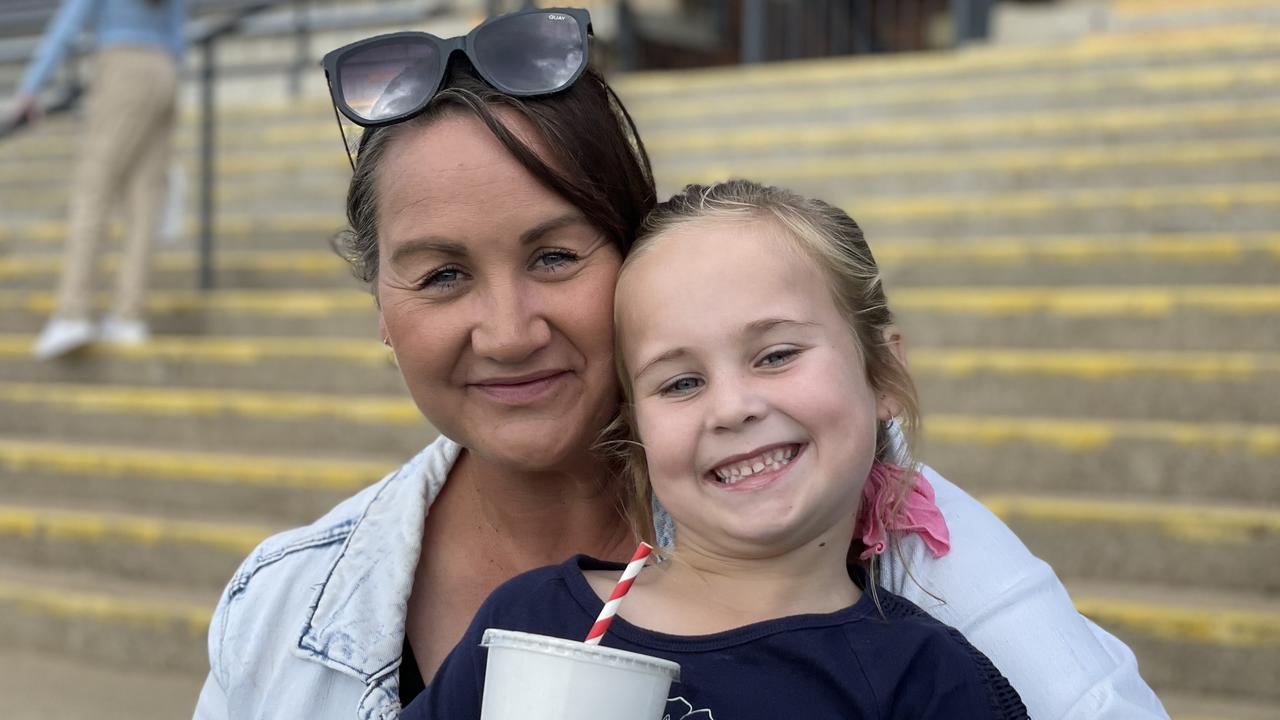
0, 232, 1280, 290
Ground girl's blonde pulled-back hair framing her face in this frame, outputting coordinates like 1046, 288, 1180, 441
602, 179, 920, 578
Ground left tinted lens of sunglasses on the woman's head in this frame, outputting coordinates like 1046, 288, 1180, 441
338, 40, 440, 122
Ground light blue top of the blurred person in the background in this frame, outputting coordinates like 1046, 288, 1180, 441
18, 0, 187, 94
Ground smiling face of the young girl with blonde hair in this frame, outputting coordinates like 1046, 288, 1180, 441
617, 219, 891, 559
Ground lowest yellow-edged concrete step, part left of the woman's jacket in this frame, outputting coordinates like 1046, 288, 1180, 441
0, 565, 219, 671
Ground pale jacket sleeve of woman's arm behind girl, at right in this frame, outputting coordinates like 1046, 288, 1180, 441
882, 465, 1169, 720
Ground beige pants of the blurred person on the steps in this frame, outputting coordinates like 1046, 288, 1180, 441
56, 47, 178, 320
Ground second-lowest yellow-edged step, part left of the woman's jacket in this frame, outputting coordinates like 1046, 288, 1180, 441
0, 502, 277, 592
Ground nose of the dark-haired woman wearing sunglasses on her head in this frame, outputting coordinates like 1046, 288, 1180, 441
471, 278, 552, 364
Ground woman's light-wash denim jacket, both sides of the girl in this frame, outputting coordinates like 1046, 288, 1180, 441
195, 437, 1167, 720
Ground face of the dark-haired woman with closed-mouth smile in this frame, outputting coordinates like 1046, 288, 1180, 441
378, 114, 621, 470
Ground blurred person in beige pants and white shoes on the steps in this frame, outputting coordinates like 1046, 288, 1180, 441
14, 0, 187, 360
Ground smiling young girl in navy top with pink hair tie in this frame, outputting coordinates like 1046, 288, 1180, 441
403, 181, 1027, 720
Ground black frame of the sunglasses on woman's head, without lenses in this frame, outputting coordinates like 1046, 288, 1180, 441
320, 8, 594, 131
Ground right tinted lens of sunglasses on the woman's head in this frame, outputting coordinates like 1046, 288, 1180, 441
474, 13, 586, 94
